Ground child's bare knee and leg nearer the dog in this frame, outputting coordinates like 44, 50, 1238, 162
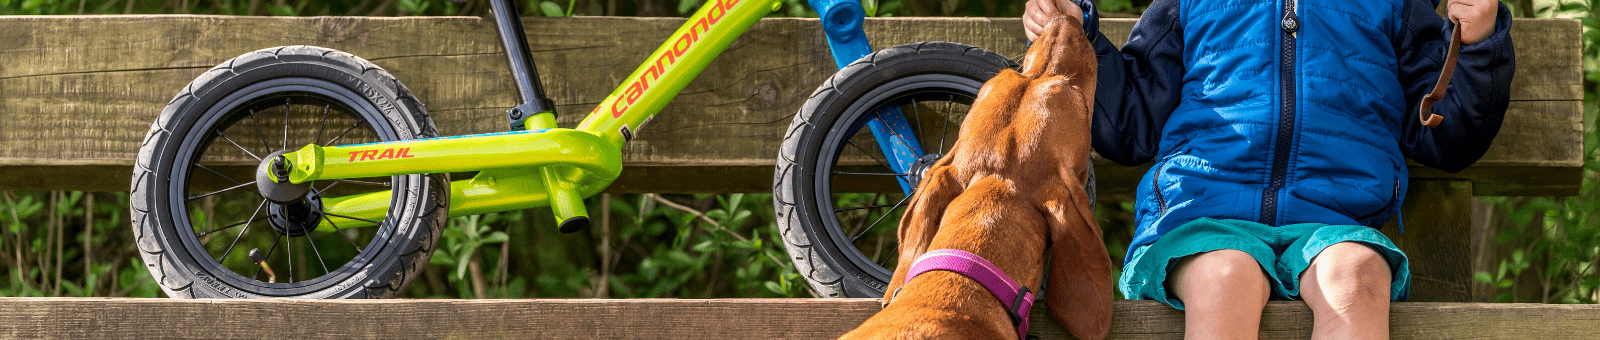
1168, 249, 1270, 338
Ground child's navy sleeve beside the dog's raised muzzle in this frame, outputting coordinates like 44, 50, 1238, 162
1090, 0, 1184, 165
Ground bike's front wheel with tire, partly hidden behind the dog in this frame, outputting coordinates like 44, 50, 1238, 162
773, 42, 1014, 298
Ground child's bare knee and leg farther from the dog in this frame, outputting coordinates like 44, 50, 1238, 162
1301, 242, 1392, 338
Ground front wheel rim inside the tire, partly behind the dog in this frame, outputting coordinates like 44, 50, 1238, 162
814, 74, 982, 282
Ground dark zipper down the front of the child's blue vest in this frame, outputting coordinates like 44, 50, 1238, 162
1261, 0, 1301, 226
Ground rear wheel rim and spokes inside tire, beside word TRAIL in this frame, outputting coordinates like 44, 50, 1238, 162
168, 79, 419, 295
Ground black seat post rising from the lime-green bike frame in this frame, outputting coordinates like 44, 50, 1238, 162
490, 0, 555, 130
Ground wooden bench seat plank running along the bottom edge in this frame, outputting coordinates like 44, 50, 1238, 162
0, 298, 1600, 338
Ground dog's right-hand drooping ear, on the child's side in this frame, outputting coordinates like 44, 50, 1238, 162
1043, 181, 1112, 338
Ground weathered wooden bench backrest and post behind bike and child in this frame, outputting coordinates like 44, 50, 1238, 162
0, 16, 1582, 302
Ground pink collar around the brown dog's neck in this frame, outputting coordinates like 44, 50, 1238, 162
894, 249, 1034, 338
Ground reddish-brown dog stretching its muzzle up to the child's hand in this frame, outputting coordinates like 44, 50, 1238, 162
845, 16, 1112, 338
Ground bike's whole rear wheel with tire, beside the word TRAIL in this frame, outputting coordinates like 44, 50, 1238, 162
131, 47, 450, 298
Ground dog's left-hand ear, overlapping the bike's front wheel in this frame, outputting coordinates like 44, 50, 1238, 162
883, 164, 965, 305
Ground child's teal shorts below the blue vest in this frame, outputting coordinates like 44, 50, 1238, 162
1118, 218, 1411, 310
